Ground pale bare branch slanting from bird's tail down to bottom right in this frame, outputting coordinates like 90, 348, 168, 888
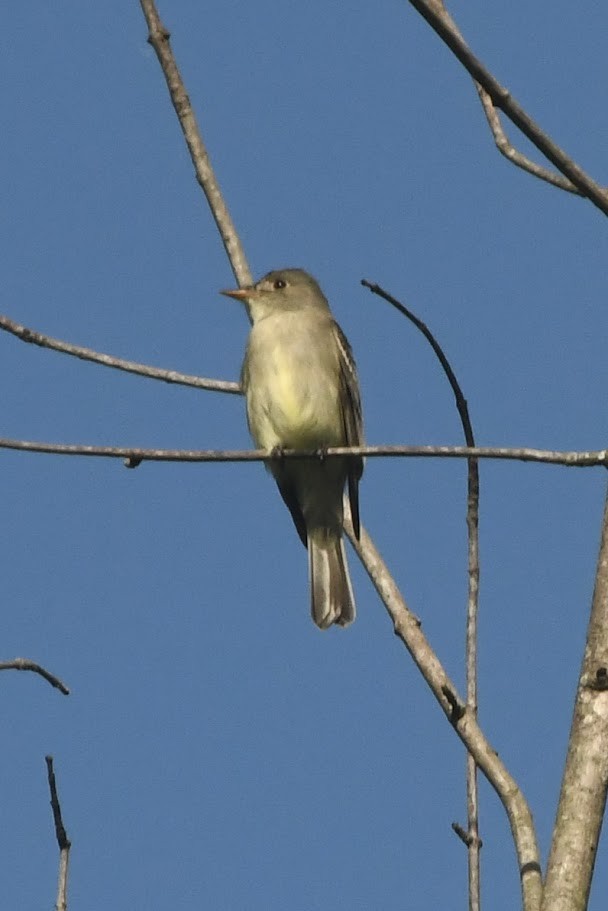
345, 500, 542, 911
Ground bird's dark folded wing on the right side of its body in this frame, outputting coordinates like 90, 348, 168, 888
333, 322, 363, 539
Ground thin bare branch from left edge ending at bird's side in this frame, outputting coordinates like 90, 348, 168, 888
0, 316, 241, 395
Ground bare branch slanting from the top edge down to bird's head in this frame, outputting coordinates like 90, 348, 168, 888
140, 0, 252, 287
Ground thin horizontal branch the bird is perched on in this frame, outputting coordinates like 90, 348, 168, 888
0, 439, 608, 468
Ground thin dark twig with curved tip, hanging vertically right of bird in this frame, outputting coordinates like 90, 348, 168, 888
361, 279, 481, 911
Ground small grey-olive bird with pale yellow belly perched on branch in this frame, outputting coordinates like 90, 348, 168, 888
222, 269, 363, 629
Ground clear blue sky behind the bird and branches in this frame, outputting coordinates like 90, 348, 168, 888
0, 0, 608, 911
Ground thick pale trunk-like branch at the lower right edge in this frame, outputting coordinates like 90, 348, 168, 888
542, 484, 608, 911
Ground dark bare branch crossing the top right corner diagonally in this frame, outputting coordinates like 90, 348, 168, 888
409, 0, 608, 215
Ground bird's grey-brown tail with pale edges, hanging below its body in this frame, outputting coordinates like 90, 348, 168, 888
308, 529, 355, 629
